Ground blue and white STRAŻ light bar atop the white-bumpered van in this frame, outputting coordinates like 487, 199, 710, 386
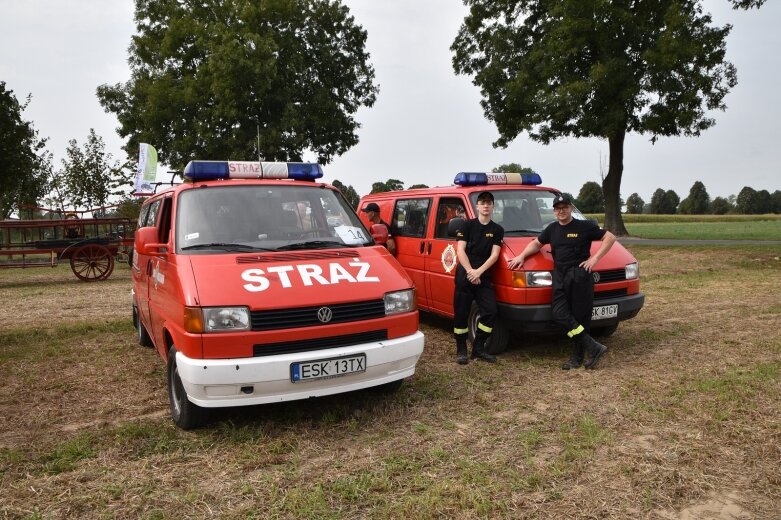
184, 161, 323, 181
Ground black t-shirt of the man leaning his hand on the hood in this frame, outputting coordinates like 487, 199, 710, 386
537, 219, 607, 268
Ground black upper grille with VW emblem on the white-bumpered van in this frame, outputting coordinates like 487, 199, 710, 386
250, 300, 385, 330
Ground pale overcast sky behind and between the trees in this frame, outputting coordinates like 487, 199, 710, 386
0, 0, 781, 202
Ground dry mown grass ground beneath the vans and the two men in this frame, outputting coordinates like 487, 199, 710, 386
0, 246, 781, 520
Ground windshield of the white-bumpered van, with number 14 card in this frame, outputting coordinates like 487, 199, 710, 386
176, 183, 373, 254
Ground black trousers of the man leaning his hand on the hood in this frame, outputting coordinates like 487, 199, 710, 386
551, 265, 594, 333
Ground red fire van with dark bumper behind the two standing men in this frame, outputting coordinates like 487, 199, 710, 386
359, 172, 645, 354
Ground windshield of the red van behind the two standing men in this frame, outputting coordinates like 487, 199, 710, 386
470, 189, 586, 235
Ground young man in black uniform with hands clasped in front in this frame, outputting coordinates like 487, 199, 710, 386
453, 191, 504, 365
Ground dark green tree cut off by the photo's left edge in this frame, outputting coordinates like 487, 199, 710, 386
0, 81, 47, 220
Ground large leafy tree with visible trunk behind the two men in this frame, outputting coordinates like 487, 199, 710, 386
451, 0, 736, 235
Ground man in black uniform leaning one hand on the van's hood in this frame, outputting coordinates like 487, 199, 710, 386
508, 194, 616, 370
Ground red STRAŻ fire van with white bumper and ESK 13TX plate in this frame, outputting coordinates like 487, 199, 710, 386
132, 161, 423, 429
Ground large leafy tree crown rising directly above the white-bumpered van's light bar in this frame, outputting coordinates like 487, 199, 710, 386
98, 0, 378, 168
